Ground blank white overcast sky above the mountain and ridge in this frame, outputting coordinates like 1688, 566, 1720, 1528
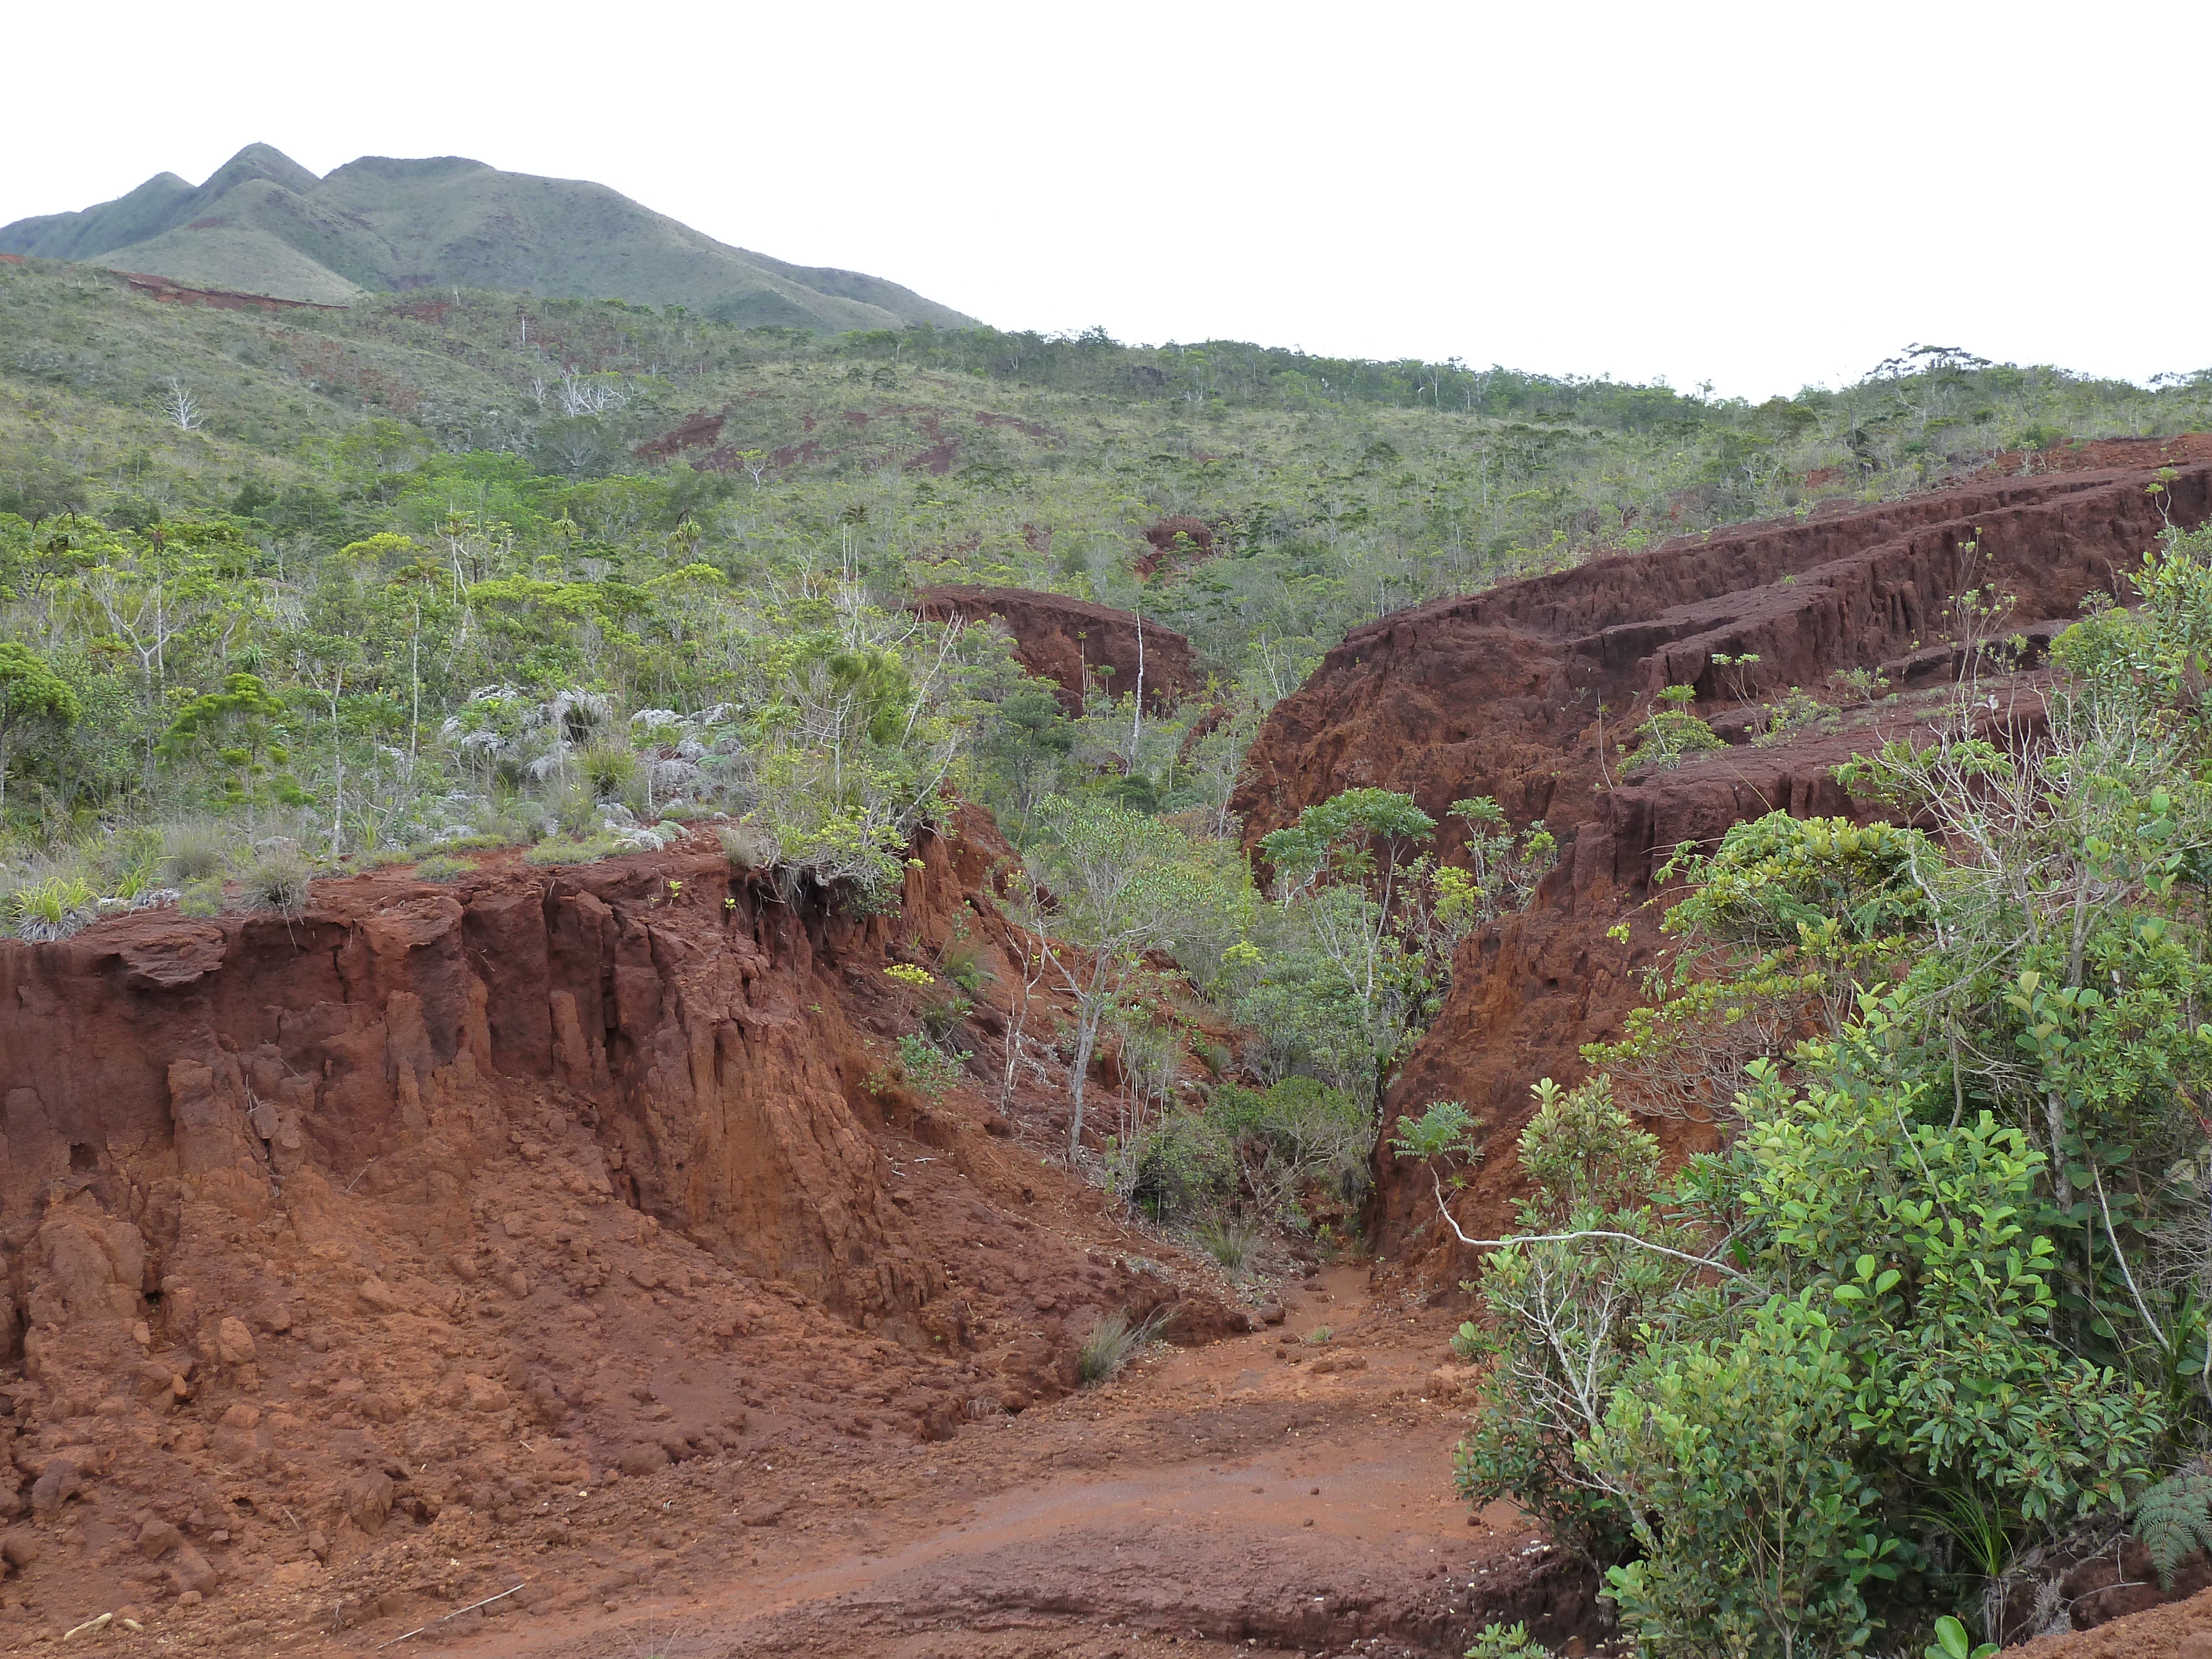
0, 0, 2212, 398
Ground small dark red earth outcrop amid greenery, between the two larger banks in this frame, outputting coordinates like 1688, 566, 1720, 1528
914, 586, 1206, 714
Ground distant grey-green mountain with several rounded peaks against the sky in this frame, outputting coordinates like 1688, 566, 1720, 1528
0, 144, 975, 330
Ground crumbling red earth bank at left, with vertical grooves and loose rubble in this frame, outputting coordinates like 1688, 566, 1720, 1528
0, 812, 1248, 1639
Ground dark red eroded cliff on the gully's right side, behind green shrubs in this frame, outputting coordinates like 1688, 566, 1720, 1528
1234, 462, 2212, 1279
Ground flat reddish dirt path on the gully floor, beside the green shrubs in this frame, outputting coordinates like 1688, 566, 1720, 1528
398, 1267, 1590, 1659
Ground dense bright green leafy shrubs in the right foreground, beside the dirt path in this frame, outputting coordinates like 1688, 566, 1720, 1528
1398, 522, 2212, 1655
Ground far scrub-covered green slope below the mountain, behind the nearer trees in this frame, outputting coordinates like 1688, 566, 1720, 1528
0, 263, 2212, 695
